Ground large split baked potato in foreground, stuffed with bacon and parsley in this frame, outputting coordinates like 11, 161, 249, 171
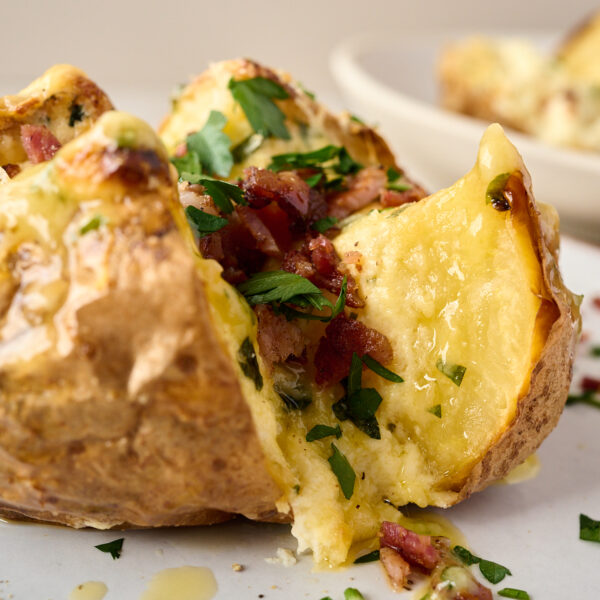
0, 61, 579, 566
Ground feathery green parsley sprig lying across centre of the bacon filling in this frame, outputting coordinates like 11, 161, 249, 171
238, 271, 348, 322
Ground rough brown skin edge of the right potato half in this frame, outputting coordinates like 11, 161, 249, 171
456, 172, 581, 502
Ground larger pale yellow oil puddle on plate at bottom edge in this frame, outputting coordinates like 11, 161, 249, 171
140, 567, 217, 600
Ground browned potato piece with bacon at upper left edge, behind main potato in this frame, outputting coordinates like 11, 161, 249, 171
0, 65, 113, 178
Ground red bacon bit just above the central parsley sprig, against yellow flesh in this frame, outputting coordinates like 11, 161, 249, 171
281, 234, 364, 308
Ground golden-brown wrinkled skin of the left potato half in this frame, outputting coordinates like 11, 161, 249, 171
0, 113, 280, 528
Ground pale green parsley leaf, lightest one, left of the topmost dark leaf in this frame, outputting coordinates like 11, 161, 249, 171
182, 110, 233, 177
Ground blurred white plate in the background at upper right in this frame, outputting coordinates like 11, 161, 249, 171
331, 32, 600, 241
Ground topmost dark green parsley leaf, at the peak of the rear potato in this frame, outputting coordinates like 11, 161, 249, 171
228, 77, 290, 140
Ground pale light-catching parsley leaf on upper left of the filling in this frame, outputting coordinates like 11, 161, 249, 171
171, 110, 233, 183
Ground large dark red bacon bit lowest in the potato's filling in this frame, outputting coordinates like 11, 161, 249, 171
315, 314, 394, 385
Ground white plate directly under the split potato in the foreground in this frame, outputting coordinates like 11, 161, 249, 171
0, 238, 600, 600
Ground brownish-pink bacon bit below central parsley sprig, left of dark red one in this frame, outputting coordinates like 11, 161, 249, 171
254, 304, 307, 369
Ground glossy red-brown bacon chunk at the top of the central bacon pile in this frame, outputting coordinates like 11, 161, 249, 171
241, 167, 311, 223
